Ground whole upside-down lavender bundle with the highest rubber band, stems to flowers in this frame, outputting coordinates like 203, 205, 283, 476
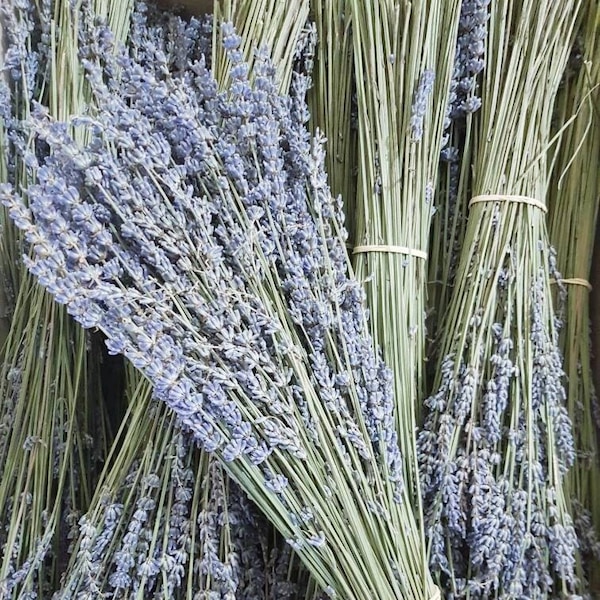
418, 1, 581, 598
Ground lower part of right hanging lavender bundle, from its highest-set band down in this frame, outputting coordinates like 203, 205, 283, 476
418, 188, 579, 597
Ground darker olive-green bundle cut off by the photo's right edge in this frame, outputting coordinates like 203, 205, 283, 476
548, 0, 600, 581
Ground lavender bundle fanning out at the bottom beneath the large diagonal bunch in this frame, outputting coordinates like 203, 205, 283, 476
56, 369, 310, 600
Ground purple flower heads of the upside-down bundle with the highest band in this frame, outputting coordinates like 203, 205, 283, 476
417, 273, 579, 598
